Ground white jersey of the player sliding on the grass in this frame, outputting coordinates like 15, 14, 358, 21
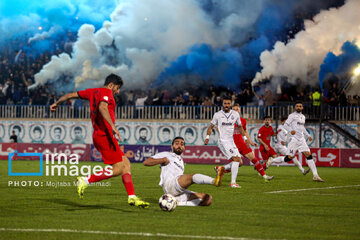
152, 152, 184, 186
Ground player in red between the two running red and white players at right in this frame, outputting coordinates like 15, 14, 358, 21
258, 116, 277, 170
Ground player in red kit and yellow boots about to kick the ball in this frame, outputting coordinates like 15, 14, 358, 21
50, 74, 149, 208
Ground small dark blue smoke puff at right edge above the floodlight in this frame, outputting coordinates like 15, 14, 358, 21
319, 41, 360, 90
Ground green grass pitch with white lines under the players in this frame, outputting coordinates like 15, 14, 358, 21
0, 160, 360, 240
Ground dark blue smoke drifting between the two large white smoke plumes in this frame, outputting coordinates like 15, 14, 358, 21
154, 4, 291, 89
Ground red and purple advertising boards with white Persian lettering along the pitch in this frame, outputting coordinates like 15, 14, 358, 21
0, 143, 360, 168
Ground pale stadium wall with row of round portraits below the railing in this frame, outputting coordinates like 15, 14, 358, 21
0, 119, 360, 148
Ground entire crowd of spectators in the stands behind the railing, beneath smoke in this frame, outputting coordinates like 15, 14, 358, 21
0, 32, 360, 109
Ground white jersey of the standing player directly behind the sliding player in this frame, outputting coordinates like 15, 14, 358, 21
211, 110, 241, 142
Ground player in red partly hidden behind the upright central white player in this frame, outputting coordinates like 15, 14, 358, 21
215, 103, 274, 182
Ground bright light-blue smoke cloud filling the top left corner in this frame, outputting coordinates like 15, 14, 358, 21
0, 0, 116, 55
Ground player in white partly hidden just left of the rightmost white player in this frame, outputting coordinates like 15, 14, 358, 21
266, 117, 310, 175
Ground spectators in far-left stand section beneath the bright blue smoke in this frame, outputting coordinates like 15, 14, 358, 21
0, 32, 75, 105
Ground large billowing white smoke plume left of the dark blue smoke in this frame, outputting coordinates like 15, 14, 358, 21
35, 0, 270, 90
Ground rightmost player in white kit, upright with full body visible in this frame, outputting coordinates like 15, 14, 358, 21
284, 101, 324, 182
